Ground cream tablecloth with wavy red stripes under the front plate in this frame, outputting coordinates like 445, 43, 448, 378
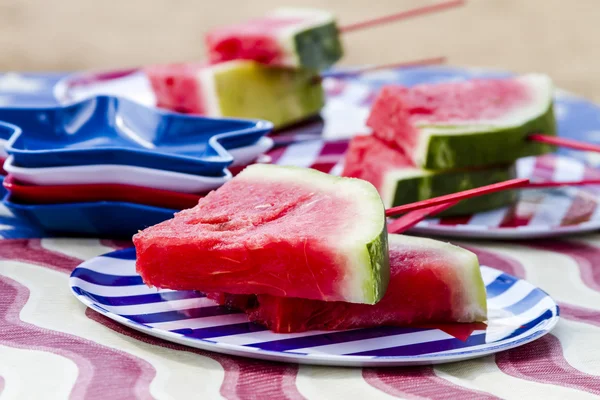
0, 70, 600, 400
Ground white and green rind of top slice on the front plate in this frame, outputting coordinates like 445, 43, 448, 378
240, 164, 390, 304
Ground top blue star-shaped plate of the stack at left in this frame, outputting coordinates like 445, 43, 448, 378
0, 96, 272, 176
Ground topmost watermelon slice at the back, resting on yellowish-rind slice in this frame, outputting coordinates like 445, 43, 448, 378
206, 9, 343, 70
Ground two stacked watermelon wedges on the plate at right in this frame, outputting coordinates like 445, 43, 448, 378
343, 74, 556, 215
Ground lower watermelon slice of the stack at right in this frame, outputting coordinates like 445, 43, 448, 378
342, 136, 517, 216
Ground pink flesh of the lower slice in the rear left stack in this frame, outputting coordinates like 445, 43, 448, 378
145, 63, 205, 114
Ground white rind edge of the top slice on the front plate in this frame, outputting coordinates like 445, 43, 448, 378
236, 164, 385, 303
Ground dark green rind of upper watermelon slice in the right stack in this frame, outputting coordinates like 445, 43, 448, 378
415, 103, 557, 169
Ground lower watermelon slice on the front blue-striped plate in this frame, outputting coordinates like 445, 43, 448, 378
210, 235, 487, 333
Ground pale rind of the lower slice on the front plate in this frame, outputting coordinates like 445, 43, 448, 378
389, 234, 487, 322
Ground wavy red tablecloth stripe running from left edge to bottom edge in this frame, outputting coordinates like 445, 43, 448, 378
0, 276, 156, 399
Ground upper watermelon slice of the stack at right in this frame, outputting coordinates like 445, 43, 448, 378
367, 74, 556, 169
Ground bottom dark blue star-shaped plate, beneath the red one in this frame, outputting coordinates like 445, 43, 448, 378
2, 194, 177, 238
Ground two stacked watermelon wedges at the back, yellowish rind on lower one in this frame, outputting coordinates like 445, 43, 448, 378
144, 9, 343, 128
